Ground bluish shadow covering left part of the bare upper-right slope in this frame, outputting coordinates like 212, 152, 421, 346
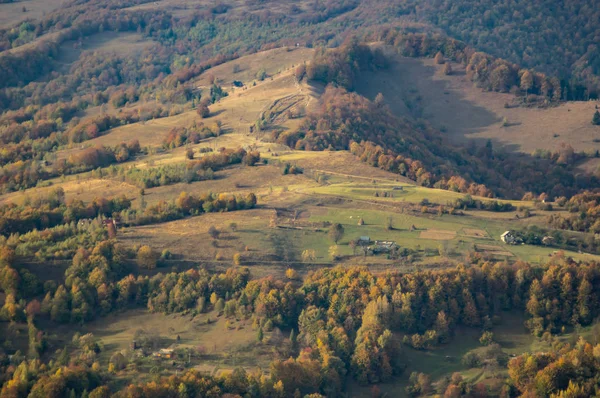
356, 58, 502, 149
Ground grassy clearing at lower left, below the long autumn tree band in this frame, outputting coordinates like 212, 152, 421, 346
77, 309, 287, 383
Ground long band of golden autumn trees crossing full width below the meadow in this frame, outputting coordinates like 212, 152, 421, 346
5, 232, 600, 396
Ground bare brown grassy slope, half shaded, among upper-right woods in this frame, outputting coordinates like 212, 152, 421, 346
357, 52, 600, 158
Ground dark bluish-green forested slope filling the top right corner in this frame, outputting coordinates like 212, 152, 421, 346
404, 0, 600, 99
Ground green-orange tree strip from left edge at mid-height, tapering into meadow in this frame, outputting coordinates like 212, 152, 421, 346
0, 184, 256, 260
